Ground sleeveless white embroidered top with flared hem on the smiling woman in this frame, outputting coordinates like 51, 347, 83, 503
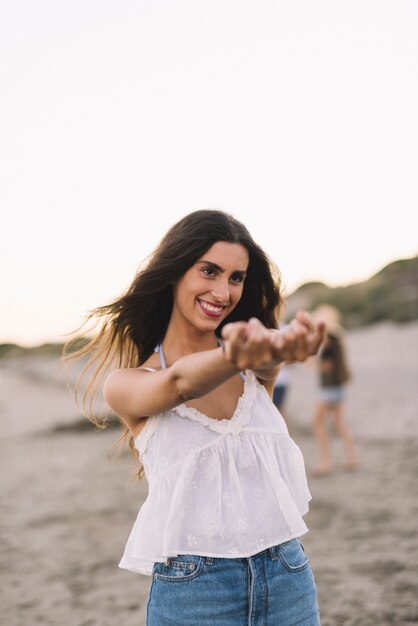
119, 371, 311, 575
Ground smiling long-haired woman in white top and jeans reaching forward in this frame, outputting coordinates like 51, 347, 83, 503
67, 210, 323, 626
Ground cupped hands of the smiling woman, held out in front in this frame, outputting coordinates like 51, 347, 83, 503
222, 311, 325, 370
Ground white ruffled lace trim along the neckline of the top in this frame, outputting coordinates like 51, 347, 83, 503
171, 370, 257, 435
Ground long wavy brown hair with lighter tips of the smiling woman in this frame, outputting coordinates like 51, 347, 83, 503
63, 209, 282, 475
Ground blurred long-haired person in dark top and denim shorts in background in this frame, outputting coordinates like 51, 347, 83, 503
313, 305, 358, 474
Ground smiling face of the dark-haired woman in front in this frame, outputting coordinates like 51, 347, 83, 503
172, 241, 249, 332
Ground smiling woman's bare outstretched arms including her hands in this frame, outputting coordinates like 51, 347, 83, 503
103, 312, 323, 431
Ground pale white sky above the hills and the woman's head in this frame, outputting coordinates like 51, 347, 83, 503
0, 0, 418, 345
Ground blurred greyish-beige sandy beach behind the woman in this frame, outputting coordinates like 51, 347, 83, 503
0, 323, 418, 626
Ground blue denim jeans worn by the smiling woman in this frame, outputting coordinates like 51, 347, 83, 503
147, 539, 319, 626
